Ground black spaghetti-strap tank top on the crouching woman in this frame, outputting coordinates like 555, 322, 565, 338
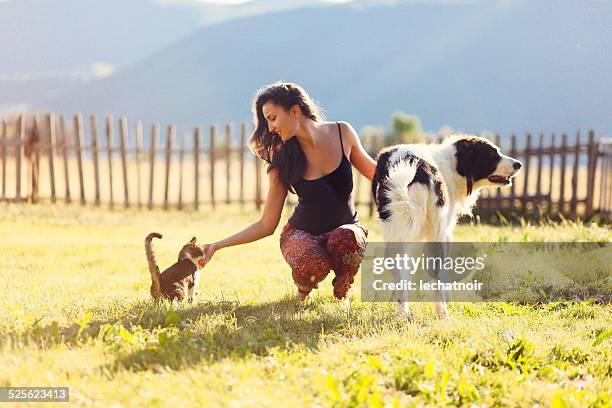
289, 122, 359, 235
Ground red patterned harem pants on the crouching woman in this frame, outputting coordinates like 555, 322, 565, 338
280, 224, 368, 299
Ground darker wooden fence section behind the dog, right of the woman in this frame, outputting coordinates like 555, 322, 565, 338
357, 130, 612, 221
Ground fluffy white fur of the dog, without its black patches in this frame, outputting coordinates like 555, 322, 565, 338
375, 135, 520, 319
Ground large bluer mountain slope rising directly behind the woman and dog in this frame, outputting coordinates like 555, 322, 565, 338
7, 0, 612, 134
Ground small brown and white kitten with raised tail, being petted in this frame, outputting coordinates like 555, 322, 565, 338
145, 232, 206, 302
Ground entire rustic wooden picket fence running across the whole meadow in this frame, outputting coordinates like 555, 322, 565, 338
0, 114, 612, 220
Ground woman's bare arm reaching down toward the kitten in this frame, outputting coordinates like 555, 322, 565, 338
203, 169, 287, 259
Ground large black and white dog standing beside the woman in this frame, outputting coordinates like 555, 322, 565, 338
372, 135, 521, 319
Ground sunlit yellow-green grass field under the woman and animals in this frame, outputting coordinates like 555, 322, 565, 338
0, 204, 612, 407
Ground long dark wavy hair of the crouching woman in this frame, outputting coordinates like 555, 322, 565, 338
250, 82, 322, 193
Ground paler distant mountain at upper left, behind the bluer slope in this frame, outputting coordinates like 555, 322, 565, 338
0, 0, 340, 112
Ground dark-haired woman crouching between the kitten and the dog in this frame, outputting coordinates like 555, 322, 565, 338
203, 82, 376, 300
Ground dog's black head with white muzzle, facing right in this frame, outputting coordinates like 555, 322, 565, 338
452, 136, 521, 195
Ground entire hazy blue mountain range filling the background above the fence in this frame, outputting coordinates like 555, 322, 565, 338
0, 0, 612, 135
